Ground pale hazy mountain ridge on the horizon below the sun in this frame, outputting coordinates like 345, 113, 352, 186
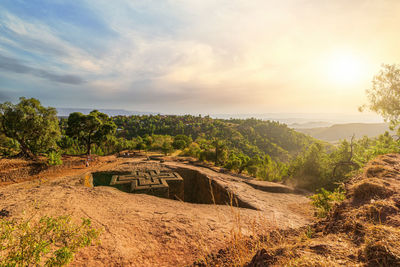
295, 123, 389, 142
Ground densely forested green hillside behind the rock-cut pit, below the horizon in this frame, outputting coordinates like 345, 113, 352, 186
113, 115, 315, 181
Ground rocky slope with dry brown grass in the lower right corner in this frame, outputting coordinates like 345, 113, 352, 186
209, 154, 400, 266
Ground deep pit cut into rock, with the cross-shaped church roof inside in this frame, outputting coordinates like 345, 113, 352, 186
84, 167, 255, 209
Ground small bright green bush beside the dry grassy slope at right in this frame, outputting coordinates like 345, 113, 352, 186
310, 186, 346, 218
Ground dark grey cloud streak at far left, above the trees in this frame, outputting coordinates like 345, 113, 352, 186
0, 55, 86, 85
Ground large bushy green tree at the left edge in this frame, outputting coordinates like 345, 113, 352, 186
0, 97, 60, 158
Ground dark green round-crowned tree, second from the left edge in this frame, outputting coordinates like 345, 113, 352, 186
66, 110, 117, 155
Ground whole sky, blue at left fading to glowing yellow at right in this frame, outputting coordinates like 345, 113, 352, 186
0, 0, 400, 114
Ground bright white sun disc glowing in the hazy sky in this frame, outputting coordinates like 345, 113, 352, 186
326, 53, 363, 86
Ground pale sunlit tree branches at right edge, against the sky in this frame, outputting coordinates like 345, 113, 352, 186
360, 64, 400, 128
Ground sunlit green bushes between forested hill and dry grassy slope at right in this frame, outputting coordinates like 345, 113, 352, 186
288, 132, 400, 191
